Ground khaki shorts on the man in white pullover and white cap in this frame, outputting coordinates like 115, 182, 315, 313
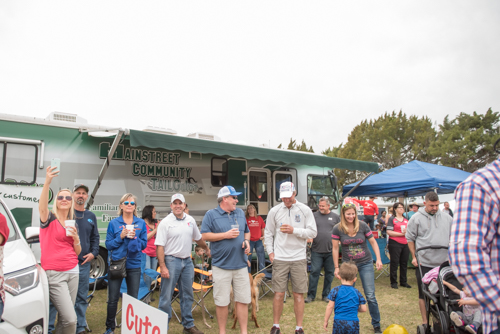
273, 259, 307, 293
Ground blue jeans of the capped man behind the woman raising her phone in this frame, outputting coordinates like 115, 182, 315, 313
49, 262, 90, 334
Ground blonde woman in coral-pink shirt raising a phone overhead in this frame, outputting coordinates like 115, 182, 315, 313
38, 166, 82, 334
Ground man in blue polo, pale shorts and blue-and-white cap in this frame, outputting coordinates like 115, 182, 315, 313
200, 186, 251, 334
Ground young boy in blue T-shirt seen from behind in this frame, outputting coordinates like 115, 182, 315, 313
323, 262, 367, 334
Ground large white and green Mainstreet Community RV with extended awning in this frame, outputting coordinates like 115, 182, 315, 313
0, 113, 378, 282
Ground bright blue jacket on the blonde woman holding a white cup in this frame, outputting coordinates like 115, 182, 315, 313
106, 216, 148, 269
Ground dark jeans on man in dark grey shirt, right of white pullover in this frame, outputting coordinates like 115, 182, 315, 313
307, 251, 335, 299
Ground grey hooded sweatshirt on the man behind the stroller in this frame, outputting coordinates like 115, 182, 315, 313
406, 207, 453, 267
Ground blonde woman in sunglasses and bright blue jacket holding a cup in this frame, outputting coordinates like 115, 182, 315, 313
105, 194, 148, 334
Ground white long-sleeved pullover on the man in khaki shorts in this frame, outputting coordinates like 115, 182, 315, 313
264, 202, 317, 261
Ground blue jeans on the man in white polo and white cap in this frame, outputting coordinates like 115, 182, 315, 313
158, 255, 194, 328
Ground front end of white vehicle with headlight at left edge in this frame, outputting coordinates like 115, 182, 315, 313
0, 199, 49, 334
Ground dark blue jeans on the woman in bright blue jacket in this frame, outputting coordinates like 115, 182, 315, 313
106, 268, 141, 330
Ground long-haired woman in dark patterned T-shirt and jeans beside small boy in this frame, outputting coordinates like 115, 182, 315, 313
332, 204, 382, 333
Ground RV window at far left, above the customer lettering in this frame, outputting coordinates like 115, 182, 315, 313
0, 143, 38, 185
